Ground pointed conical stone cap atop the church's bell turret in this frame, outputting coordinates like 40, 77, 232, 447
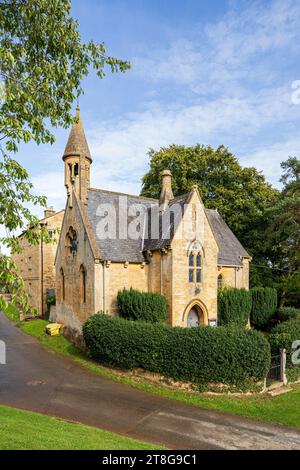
63, 105, 92, 161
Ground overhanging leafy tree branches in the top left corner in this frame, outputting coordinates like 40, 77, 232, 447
0, 0, 129, 151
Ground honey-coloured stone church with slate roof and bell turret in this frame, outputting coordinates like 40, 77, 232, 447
52, 109, 251, 339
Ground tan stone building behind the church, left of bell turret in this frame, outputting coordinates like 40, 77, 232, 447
12, 209, 64, 315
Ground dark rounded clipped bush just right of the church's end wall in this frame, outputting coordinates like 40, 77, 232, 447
250, 287, 277, 329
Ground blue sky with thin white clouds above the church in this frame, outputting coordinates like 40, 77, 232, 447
19, 0, 300, 213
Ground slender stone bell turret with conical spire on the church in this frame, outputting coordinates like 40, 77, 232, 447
63, 106, 92, 207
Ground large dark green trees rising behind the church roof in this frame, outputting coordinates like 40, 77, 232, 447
142, 145, 300, 308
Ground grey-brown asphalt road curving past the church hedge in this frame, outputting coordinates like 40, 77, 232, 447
0, 313, 300, 449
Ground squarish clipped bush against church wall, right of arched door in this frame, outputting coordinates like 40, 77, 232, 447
218, 289, 252, 327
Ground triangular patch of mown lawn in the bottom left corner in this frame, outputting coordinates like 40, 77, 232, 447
0, 405, 159, 450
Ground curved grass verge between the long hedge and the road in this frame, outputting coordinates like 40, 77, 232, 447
21, 320, 300, 427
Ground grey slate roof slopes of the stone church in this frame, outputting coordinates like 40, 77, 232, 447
87, 189, 249, 266
